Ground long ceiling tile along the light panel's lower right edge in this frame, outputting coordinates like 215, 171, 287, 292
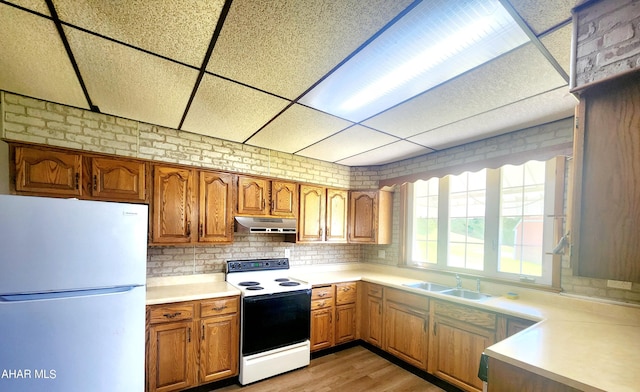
363, 44, 567, 138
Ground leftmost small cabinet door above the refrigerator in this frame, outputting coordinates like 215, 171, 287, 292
15, 147, 82, 196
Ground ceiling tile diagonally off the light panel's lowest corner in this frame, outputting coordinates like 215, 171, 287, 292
296, 125, 398, 162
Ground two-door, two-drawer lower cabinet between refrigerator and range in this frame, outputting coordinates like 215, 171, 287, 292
146, 296, 240, 392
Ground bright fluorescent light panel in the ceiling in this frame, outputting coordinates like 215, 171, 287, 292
300, 0, 529, 122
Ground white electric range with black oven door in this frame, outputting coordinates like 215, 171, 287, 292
226, 258, 311, 385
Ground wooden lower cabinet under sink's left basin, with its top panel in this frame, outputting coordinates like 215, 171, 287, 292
384, 289, 429, 370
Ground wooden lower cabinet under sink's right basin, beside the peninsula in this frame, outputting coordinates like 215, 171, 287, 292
429, 301, 497, 391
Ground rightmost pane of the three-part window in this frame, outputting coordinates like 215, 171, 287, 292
498, 161, 545, 276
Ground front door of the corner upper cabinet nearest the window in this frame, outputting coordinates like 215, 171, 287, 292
349, 191, 378, 244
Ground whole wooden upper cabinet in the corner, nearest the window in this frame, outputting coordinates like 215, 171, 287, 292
349, 190, 393, 244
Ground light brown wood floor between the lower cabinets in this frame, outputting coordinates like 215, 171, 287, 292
215, 346, 444, 392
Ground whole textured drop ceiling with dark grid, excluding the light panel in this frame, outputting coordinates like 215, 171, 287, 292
0, 0, 577, 166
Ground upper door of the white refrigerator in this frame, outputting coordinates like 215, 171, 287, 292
0, 195, 148, 294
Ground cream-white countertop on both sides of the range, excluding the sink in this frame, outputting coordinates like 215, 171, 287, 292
147, 263, 640, 392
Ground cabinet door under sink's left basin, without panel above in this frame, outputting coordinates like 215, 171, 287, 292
384, 302, 429, 370
